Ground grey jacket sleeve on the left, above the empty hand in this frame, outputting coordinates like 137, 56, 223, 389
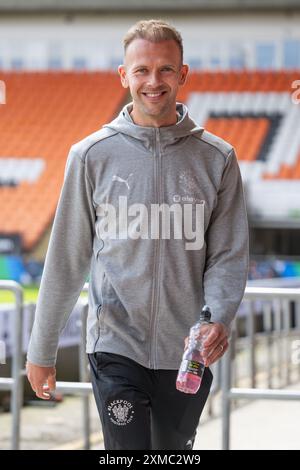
27, 147, 95, 366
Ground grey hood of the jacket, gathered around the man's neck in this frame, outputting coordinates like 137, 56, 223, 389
103, 102, 204, 149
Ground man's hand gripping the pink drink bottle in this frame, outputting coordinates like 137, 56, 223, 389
184, 323, 229, 367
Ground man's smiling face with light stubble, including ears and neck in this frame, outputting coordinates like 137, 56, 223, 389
118, 38, 188, 127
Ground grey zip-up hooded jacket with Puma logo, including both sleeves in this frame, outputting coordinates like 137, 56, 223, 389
27, 103, 248, 369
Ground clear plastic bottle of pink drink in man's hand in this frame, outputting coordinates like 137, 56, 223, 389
176, 305, 211, 393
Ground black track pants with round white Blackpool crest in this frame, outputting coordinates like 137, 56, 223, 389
88, 352, 212, 450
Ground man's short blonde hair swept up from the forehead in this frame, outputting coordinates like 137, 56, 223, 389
123, 20, 183, 63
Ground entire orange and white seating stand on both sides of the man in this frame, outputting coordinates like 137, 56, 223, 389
0, 70, 300, 258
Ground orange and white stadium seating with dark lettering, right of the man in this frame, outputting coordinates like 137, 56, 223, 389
180, 70, 300, 182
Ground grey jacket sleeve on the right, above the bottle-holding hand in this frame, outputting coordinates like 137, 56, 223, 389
203, 149, 249, 328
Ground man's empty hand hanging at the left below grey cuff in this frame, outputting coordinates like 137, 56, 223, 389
26, 362, 56, 400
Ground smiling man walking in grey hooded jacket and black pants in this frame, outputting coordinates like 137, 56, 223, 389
27, 20, 248, 449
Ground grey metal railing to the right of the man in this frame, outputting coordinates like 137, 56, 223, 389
221, 287, 300, 450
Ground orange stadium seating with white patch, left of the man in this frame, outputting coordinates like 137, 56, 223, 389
0, 71, 126, 251
